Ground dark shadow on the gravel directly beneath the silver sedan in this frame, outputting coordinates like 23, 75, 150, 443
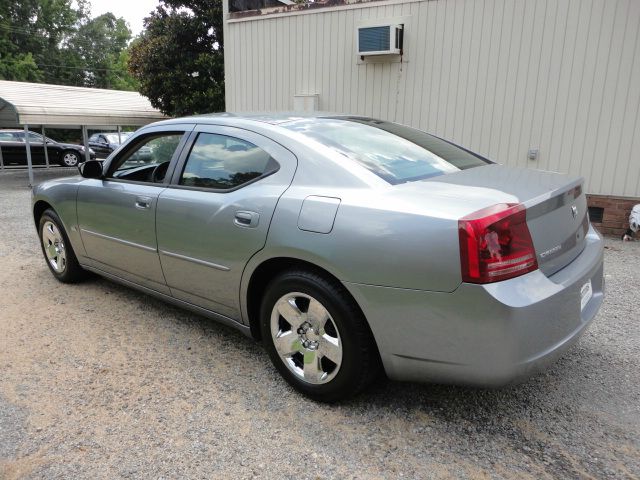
77, 270, 629, 428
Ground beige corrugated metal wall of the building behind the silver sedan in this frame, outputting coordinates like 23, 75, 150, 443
225, 0, 640, 197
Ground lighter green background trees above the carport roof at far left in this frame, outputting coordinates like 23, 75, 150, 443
0, 0, 136, 90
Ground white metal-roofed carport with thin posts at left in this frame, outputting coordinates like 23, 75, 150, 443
0, 80, 166, 185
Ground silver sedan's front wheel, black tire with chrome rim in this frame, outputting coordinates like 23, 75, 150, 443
38, 208, 88, 283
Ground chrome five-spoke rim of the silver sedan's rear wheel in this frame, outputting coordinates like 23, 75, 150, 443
271, 292, 343, 385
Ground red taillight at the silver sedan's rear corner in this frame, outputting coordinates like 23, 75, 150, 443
458, 203, 538, 283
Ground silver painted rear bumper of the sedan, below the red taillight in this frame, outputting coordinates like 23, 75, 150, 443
345, 226, 604, 387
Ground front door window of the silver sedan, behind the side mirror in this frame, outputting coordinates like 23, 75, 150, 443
107, 132, 183, 182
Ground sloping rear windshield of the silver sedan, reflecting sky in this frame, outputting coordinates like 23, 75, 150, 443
280, 117, 490, 185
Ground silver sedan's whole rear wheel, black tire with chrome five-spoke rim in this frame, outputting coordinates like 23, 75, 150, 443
261, 271, 380, 402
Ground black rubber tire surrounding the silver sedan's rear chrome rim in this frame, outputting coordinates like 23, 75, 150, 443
260, 270, 380, 402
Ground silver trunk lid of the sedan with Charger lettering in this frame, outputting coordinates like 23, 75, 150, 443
425, 164, 589, 276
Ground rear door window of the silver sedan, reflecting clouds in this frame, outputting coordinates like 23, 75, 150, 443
180, 133, 278, 190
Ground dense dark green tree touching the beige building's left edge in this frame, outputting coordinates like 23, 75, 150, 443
129, 0, 224, 116
